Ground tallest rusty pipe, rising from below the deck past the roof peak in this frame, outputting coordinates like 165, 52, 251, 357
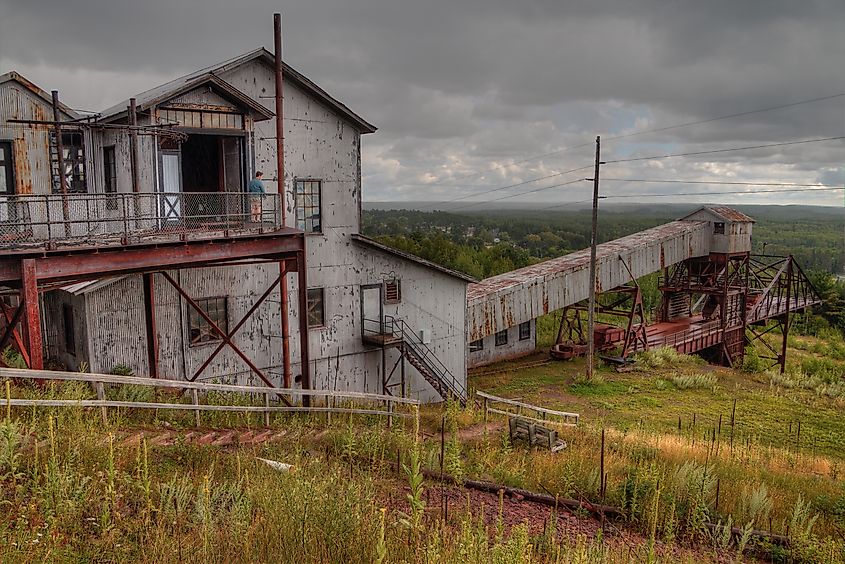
273, 13, 294, 388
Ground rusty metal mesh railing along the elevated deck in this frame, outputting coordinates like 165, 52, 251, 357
0, 192, 282, 249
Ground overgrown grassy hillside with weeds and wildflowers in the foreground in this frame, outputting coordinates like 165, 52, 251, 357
0, 330, 845, 563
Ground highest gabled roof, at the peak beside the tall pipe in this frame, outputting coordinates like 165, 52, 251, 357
95, 47, 376, 133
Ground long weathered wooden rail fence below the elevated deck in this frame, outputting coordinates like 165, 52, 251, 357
0, 368, 420, 426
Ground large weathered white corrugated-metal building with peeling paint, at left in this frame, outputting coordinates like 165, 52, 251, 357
0, 48, 473, 400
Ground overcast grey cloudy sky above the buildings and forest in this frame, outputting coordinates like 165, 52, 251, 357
0, 0, 845, 210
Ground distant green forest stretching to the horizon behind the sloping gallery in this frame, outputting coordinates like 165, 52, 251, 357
363, 205, 845, 279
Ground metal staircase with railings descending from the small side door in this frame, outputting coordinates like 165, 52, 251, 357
363, 315, 467, 406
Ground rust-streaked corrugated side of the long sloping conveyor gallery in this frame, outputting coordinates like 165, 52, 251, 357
467, 221, 710, 341
